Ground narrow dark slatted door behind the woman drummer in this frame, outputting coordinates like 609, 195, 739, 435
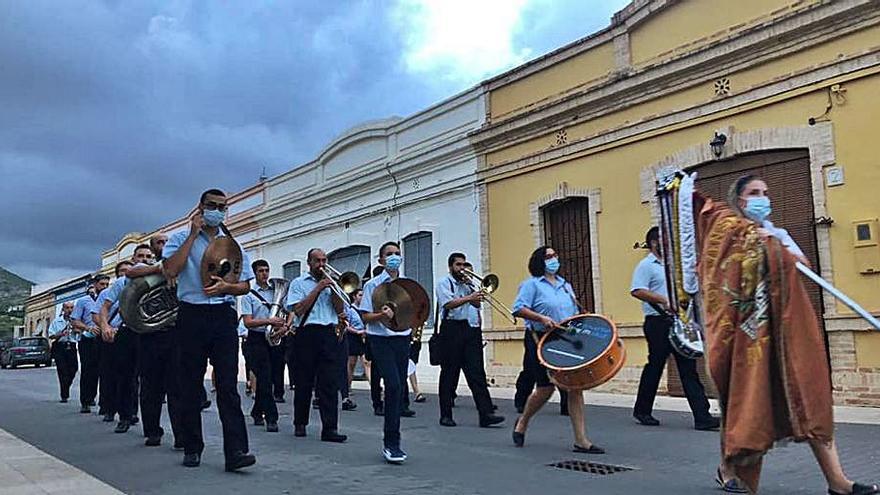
541, 197, 595, 312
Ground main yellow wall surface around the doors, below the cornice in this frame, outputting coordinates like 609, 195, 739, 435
487, 75, 880, 332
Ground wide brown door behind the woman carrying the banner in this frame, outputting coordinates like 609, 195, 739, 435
667, 150, 828, 395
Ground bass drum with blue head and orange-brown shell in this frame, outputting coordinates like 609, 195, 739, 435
538, 314, 626, 390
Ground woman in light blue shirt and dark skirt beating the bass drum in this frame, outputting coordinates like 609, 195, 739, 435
513, 246, 605, 454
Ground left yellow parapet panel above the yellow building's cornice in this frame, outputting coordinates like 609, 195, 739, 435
490, 43, 614, 121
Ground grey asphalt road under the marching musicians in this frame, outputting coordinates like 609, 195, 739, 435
0, 368, 880, 495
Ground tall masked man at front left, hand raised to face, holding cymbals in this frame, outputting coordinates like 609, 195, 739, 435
162, 189, 256, 471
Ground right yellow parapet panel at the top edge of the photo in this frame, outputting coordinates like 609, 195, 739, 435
630, 0, 814, 65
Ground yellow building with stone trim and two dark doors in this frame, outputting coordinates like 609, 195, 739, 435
471, 0, 880, 406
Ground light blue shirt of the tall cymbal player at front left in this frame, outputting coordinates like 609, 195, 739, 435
162, 230, 254, 304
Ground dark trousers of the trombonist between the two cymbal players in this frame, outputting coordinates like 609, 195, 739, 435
292, 325, 341, 432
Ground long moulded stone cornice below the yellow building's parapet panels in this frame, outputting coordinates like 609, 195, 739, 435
471, 0, 880, 153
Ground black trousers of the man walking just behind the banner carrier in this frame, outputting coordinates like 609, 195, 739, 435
633, 316, 710, 423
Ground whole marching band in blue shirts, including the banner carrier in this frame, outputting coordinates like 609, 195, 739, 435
43, 186, 880, 495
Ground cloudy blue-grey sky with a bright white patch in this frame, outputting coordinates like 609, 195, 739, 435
0, 0, 627, 282
